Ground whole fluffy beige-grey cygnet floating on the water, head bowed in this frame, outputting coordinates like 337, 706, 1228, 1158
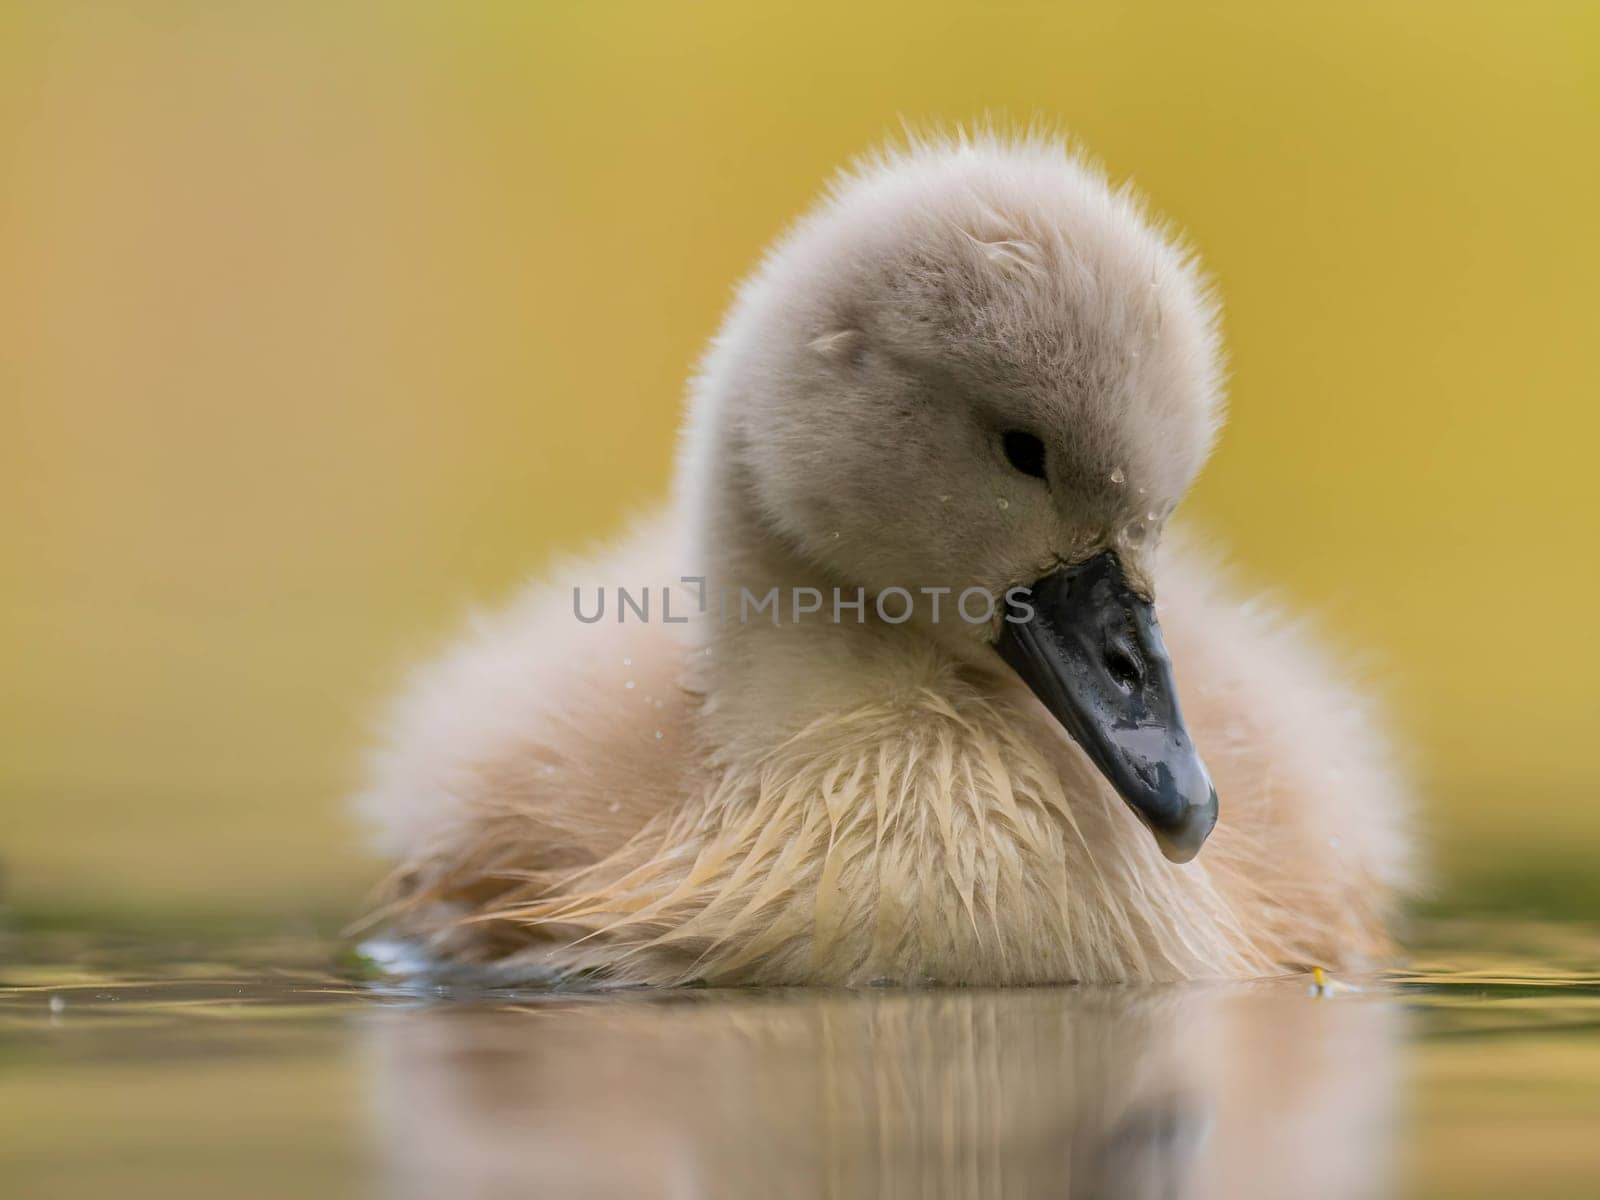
363, 136, 1406, 984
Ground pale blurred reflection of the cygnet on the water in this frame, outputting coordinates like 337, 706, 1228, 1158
363, 982, 1400, 1197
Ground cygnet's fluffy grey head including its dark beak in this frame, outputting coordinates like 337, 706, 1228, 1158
686, 136, 1221, 861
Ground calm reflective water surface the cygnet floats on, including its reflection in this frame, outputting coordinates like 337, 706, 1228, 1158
0, 925, 1600, 1198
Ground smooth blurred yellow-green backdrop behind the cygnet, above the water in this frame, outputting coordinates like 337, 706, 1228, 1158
0, 0, 1600, 920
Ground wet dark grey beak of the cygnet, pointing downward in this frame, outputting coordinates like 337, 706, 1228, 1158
995, 550, 1216, 862
